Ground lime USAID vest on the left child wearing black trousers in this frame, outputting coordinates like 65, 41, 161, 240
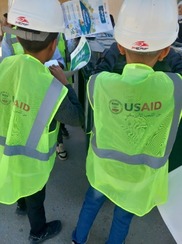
0, 54, 67, 204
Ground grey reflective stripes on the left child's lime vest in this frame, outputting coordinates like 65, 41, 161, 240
0, 78, 63, 161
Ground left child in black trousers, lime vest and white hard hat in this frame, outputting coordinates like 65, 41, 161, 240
0, 0, 84, 244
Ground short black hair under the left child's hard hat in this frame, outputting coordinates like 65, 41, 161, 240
17, 27, 59, 53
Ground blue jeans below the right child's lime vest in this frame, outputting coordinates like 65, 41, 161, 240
72, 186, 133, 244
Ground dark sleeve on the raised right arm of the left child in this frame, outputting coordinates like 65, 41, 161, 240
54, 85, 84, 126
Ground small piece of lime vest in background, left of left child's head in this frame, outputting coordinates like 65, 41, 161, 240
4, 33, 24, 55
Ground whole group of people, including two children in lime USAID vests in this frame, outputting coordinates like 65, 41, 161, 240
0, 0, 182, 244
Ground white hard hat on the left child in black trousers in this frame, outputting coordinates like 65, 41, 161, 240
5, 0, 64, 39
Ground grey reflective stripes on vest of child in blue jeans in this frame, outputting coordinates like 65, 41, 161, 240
89, 73, 182, 169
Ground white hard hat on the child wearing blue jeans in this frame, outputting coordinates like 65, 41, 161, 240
114, 0, 179, 52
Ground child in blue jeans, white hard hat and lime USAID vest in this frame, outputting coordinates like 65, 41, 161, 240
72, 0, 182, 244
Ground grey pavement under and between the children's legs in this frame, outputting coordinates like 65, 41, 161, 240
0, 126, 176, 244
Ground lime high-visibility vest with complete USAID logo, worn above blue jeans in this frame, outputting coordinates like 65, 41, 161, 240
86, 64, 182, 216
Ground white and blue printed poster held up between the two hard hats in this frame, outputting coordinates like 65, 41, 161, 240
62, 0, 113, 40
